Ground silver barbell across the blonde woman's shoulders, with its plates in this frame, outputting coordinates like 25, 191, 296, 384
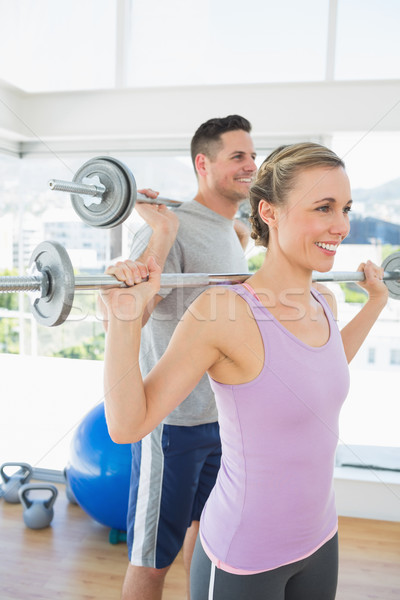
0, 241, 400, 327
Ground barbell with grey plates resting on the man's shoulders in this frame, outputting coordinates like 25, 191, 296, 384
48, 156, 182, 229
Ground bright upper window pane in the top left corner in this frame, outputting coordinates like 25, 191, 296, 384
0, 0, 116, 92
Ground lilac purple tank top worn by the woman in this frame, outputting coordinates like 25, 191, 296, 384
200, 285, 349, 571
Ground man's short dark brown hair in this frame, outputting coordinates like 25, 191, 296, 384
190, 115, 251, 171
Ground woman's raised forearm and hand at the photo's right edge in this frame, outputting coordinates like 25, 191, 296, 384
341, 261, 389, 363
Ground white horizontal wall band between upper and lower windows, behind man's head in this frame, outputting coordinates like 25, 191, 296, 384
0, 80, 400, 154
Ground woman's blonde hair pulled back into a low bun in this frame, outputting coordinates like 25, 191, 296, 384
249, 142, 345, 247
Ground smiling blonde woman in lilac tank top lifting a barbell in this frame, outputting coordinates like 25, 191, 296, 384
103, 143, 388, 600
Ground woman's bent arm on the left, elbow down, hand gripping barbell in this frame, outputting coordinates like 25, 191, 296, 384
102, 259, 220, 444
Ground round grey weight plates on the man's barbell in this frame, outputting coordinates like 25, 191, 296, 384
71, 156, 136, 228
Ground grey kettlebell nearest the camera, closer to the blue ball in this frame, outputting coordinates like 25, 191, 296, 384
18, 483, 58, 529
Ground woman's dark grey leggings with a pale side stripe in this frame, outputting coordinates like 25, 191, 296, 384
190, 534, 338, 600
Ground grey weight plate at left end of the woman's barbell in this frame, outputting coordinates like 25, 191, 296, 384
29, 242, 75, 327
